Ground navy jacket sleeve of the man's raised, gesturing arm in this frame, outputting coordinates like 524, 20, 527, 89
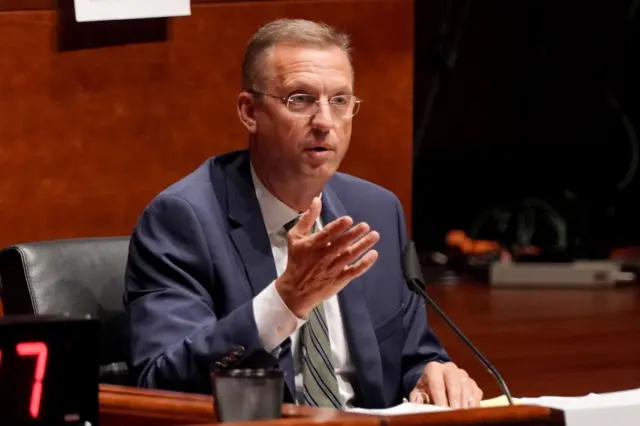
125, 195, 277, 393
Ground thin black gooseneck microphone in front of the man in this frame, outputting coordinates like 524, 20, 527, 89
403, 241, 513, 405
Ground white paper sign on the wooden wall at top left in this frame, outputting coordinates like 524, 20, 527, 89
74, 0, 191, 22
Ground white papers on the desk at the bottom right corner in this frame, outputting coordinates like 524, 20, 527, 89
520, 388, 640, 426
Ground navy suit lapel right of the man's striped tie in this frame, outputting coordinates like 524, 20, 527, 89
321, 185, 384, 407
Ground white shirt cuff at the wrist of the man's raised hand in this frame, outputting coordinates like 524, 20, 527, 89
253, 281, 306, 352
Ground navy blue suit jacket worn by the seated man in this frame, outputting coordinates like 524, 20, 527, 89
125, 151, 448, 408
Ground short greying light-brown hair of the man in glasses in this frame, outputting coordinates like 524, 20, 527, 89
242, 19, 353, 90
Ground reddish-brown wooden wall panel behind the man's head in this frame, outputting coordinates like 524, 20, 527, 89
0, 0, 413, 246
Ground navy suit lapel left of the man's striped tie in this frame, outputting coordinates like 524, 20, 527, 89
226, 152, 295, 395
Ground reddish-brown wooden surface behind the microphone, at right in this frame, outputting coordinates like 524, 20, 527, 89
428, 283, 640, 398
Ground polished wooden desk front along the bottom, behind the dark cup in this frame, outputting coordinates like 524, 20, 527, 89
100, 385, 564, 426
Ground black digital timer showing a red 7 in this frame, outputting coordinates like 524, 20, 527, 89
0, 316, 100, 426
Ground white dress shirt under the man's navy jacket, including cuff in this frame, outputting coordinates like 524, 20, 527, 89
251, 166, 355, 406
